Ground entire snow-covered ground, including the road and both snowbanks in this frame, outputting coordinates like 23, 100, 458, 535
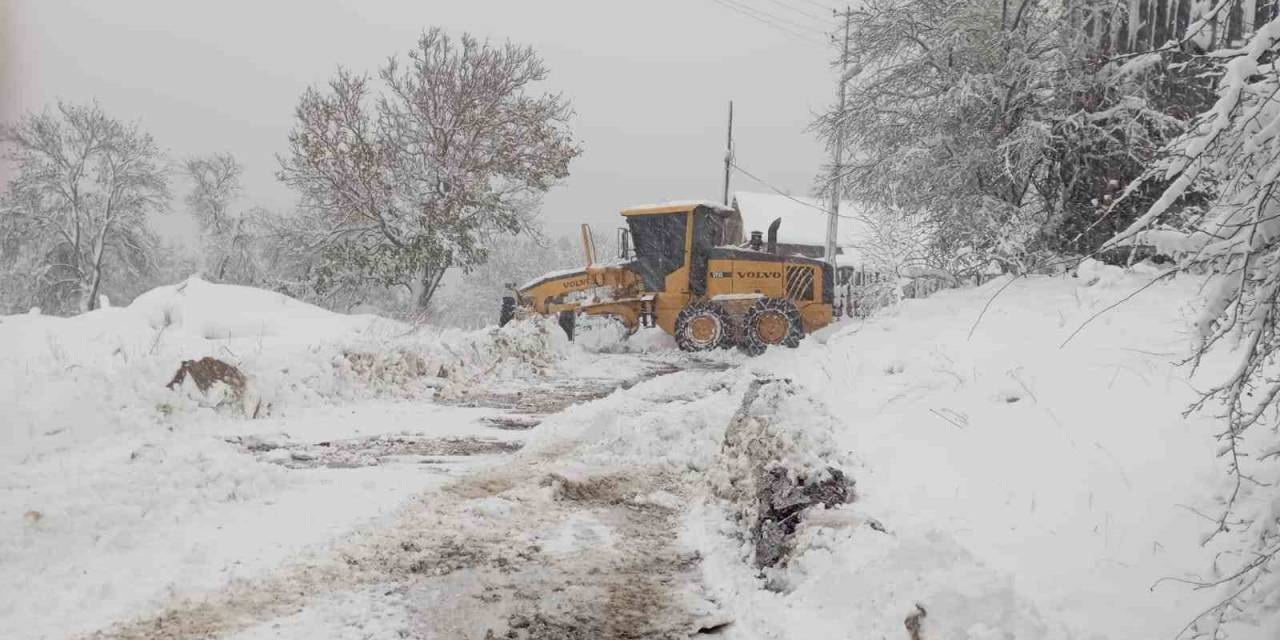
0, 264, 1280, 640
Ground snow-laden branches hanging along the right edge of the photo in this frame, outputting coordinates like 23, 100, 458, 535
1111, 19, 1280, 637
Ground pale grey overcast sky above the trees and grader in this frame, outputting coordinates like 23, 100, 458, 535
0, 0, 835, 238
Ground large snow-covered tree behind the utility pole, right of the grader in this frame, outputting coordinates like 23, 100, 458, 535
815, 0, 1206, 271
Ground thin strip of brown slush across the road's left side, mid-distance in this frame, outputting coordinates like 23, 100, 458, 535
228, 435, 521, 468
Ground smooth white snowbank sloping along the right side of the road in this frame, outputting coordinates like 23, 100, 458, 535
711, 264, 1280, 640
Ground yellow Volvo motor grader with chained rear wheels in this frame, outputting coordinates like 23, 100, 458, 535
499, 202, 835, 353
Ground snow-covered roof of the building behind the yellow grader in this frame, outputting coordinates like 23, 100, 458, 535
733, 191, 867, 251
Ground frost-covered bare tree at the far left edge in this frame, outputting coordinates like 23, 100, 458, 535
0, 102, 169, 311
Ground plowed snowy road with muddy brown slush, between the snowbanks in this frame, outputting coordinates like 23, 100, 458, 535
35, 355, 724, 639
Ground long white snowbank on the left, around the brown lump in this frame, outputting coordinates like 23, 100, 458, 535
0, 278, 568, 461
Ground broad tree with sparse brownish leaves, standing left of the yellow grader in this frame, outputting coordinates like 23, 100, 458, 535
279, 28, 580, 311
